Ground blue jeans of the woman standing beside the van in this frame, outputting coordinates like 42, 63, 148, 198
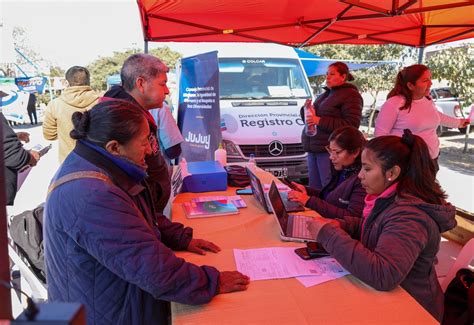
308, 152, 331, 190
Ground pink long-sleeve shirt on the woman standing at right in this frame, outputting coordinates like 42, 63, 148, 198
375, 96, 459, 159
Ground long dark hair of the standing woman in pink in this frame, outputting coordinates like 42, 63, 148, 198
387, 64, 429, 111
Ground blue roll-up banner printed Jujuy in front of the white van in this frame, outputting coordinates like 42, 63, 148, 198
178, 51, 222, 161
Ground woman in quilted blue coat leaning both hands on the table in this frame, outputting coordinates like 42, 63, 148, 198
44, 100, 249, 324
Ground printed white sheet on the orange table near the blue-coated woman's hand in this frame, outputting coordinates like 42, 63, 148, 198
234, 247, 340, 281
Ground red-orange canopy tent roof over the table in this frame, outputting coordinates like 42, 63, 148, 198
137, 0, 474, 47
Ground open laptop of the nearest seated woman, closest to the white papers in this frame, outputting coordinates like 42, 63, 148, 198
268, 182, 316, 243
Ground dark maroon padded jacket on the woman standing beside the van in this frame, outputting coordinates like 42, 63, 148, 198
300, 83, 363, 152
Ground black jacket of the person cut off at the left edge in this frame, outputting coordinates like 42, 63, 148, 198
0, 113, 30, 205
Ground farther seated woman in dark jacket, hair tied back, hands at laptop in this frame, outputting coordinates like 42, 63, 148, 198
288, 126, 366, 219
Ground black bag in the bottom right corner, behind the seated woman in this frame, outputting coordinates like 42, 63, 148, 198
443, 269, 474, 325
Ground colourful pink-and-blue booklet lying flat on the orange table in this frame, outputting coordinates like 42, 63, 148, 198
183, 200, 239, 219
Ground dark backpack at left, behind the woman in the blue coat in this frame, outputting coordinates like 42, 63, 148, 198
10, 204, 46, 283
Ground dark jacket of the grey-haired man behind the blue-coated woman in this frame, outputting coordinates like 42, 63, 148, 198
104, 86, 171, 213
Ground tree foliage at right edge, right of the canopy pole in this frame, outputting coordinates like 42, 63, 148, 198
426, 44, 474, 106
